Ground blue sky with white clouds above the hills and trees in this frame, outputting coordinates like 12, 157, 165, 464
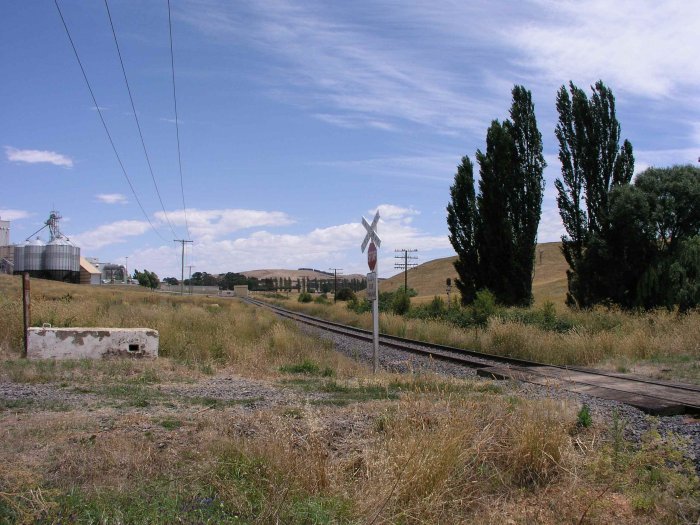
0, 0, 700, 278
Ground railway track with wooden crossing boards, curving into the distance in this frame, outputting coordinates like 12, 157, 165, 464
246, 298, 700, 416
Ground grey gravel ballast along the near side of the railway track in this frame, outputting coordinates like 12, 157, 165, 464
299, 324, 700, 473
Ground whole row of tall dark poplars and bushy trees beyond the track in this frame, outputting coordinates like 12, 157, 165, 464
447, 81, 700, 311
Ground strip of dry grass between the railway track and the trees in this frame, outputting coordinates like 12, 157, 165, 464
283, 301, 700, 383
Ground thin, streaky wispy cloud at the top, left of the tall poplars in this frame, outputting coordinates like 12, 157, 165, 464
182, 0, 497, 133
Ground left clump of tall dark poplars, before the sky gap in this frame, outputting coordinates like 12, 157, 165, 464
447, 86, 546, 305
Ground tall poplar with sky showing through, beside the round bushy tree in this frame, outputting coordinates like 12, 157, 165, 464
554, 81, 634, 307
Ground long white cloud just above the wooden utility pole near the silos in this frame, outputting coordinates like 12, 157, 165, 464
155, 209, 294, 242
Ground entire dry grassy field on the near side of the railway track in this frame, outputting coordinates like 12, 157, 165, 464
0, 276, 700, 524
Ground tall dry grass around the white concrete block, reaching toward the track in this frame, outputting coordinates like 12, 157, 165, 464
0, 276, 366, 382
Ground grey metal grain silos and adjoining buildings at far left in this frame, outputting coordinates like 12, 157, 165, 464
0, 211, 100, 284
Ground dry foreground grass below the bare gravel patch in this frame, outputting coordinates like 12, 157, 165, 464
0, 386, 700, 524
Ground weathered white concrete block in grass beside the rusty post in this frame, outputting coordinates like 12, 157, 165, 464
27, 327, 159, 359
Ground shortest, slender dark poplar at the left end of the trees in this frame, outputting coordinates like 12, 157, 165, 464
447, 156, 478, 304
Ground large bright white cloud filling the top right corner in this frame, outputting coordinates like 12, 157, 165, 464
508, 0, 700, 98
